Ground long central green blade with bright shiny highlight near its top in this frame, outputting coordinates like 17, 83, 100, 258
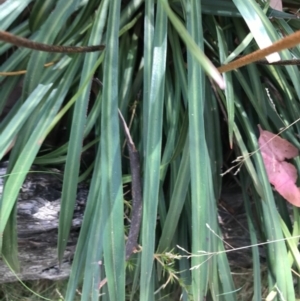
140, 2, 167, 301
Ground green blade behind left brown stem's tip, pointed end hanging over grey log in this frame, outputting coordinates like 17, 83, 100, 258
57, 0, 105, 262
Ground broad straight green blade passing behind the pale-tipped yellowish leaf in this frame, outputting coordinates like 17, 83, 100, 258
186, 1, 212, 300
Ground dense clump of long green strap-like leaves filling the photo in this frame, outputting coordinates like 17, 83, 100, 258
0, 0, 300, 301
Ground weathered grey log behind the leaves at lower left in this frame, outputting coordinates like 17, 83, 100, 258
0, 163, 88, 283
